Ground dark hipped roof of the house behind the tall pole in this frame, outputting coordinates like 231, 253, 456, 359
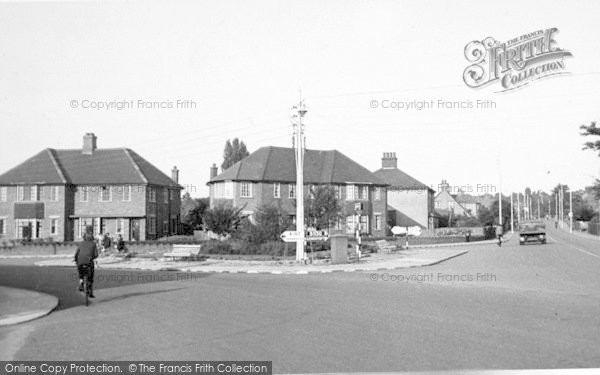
209, 146, 387, 186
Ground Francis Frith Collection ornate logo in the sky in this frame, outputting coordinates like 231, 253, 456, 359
463, 27, 572, 91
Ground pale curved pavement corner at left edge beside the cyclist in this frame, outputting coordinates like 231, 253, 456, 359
0, 286, 58, 327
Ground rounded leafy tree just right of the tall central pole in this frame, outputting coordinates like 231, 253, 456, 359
304, 185, 342, 229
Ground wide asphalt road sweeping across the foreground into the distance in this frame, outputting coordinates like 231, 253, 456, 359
0, 223, 600, 373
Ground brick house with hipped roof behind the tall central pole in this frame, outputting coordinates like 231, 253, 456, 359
208, 147, 387, 236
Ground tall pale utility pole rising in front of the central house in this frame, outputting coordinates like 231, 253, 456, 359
291, 98, 307, 261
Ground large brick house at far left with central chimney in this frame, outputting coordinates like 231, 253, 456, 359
0, 133, 182, 242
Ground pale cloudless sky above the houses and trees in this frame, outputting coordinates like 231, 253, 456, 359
0, 0, 600, 197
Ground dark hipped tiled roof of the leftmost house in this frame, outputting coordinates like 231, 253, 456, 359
0, 148, 179, 187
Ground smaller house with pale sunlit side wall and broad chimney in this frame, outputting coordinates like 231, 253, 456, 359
373, 152, 436, 229
